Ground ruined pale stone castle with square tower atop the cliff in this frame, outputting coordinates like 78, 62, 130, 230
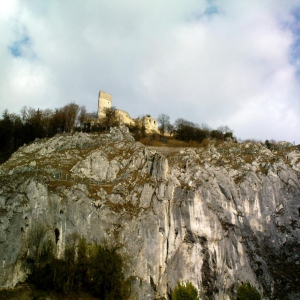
98, 91, 158, 133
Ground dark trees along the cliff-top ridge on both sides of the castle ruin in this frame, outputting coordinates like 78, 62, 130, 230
0, 102, 234, 164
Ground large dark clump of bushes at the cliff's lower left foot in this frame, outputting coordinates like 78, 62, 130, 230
27, 224, 130, 300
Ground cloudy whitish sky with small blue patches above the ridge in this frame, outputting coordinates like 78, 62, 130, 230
0, 0, 300, 144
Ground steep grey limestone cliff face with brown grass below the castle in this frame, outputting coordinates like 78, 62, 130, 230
0, 127, 300, 300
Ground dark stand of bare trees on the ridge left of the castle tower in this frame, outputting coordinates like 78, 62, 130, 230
0, 103, 95, 163
